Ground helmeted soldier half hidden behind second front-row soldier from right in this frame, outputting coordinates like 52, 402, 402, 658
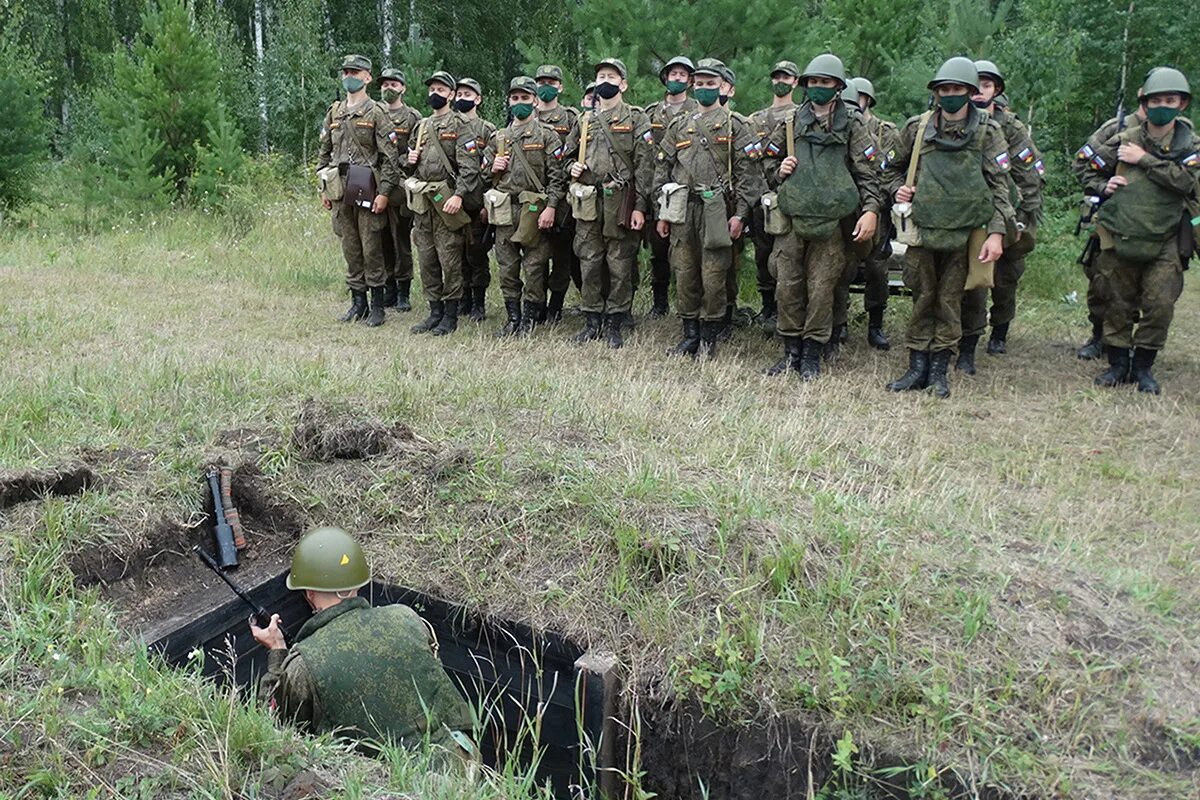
954, 61, 1045, 375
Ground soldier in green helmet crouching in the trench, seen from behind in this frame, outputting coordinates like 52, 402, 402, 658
250, 528, 475, 772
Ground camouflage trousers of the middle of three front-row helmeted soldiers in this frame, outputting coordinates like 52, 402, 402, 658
904, 247, 967, 351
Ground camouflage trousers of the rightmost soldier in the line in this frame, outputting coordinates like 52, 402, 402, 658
1096, 236, 1183, 350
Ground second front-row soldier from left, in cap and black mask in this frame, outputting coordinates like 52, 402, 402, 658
404, 72, 481, 336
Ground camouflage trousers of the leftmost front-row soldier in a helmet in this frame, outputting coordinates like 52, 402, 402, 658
774, 228, 846, 344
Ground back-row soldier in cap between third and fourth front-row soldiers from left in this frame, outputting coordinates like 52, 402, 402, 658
533, 64, 583, 323
